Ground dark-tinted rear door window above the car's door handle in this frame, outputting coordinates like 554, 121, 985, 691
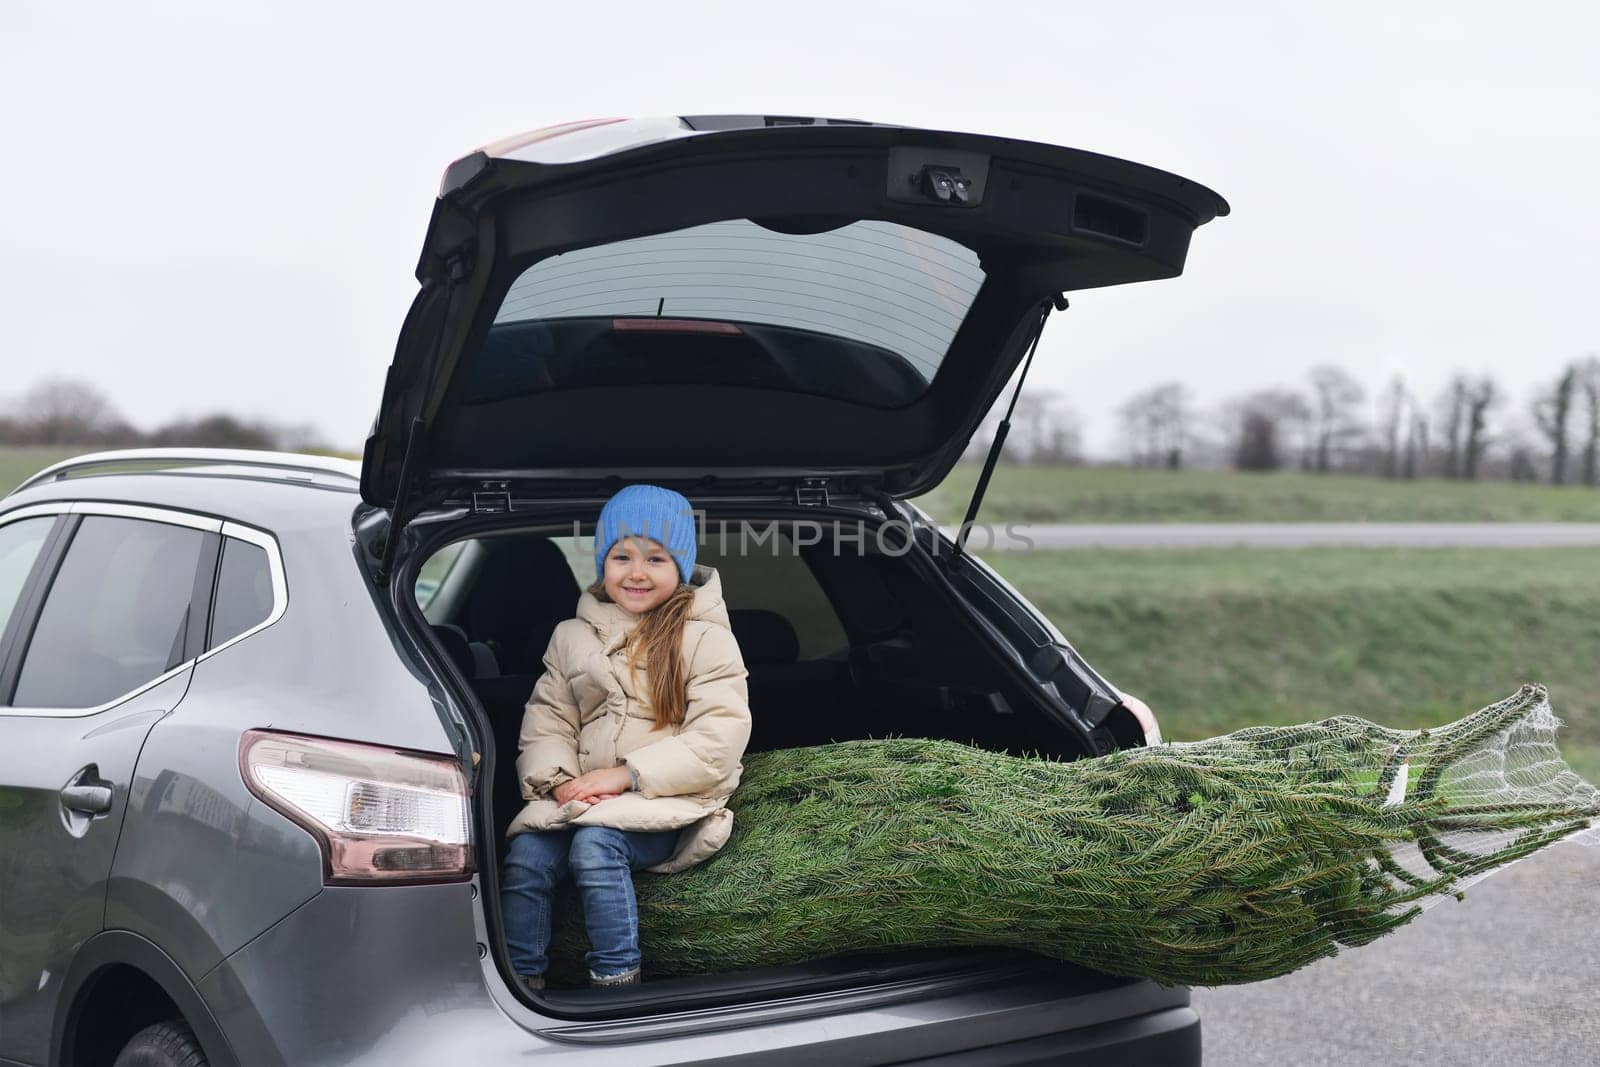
11, 515, 205, 707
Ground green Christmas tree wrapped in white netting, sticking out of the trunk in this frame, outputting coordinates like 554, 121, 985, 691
552, 686, 1600, 985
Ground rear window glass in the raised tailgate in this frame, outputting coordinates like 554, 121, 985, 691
469, 219, 984, 406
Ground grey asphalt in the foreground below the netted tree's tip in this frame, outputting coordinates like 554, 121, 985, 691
1195, 843, 1600, 1067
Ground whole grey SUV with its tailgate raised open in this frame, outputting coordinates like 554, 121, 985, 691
0, 117, 1227, 1065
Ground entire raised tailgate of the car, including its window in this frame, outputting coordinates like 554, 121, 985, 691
362, 117, 1227, 511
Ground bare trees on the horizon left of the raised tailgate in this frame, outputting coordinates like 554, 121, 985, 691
0, 378, 325, 451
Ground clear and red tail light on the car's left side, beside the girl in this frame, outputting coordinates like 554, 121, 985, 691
238, 729, 474, 885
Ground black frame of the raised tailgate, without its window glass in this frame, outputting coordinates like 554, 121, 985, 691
362, 117, 1227, 507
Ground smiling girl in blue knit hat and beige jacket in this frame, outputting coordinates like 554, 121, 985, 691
501, 485, 750, 990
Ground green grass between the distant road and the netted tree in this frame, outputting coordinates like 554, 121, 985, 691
986, 549, 1600, 781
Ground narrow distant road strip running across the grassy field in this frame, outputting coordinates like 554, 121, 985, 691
940, 523, 1600, 552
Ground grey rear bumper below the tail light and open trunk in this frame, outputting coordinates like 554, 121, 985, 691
198, 885, 1200, 1067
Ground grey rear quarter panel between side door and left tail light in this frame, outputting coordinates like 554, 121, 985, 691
90, 480, 466, 981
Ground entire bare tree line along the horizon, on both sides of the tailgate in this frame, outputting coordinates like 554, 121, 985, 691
15, 363, 1600, 486
